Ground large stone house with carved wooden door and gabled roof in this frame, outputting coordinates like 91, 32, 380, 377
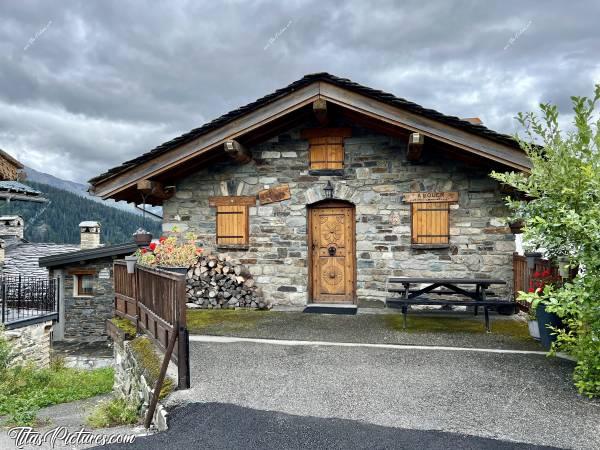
90, 74, 531, 306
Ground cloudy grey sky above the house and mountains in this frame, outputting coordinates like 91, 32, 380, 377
0, 0, 600, 182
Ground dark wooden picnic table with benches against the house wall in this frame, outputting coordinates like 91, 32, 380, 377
385, 277, 514, 333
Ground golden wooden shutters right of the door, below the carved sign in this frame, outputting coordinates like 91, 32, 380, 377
411, 202, 450, 244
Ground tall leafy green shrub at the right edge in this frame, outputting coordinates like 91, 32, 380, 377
492, 85, 600, 397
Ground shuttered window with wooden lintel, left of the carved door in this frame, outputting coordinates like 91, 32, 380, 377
209, 197, 256, 247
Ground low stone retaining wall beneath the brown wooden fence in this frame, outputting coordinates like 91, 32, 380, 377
113, 341, 177, 431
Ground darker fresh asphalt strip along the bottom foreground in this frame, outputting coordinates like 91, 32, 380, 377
97, 403, 555, 450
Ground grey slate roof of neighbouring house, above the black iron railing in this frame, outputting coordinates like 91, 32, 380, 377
0, 236, 79, 278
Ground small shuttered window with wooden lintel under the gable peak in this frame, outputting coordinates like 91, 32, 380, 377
302, 128, 351, 170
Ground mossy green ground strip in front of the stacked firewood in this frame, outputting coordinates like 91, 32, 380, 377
186, 309, 264, 334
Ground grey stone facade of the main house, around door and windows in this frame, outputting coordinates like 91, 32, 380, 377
163, 123, 515, 305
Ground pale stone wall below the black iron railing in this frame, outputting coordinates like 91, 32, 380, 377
4, 320, 52, 368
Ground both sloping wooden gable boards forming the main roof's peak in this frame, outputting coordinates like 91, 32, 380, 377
92, 81, 531, 199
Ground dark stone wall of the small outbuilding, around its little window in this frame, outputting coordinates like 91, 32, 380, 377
50, 258, 114, 342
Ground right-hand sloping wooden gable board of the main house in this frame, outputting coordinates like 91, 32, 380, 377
319, 81, 531, 172
